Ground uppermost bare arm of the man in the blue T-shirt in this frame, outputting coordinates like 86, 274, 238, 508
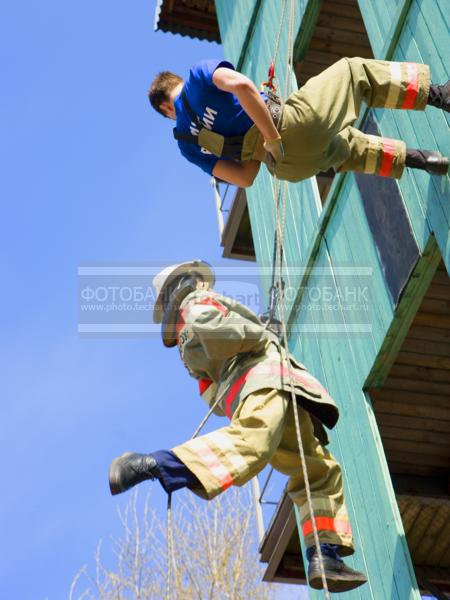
212, 67, 279, 140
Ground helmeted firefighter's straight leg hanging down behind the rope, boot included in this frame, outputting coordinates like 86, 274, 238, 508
270, 400, 366, 592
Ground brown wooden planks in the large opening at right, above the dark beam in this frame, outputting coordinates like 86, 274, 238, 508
370, 264, 450, 480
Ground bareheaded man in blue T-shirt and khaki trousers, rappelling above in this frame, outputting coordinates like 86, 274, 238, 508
149, 58, 450, 187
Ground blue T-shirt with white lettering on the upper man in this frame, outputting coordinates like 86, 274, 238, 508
174, 60, 253, 175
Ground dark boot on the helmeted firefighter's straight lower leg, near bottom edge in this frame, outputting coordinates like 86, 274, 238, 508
308, 554, 367, 594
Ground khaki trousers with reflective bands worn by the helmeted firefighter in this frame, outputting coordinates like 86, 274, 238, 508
172, 389, 354, 556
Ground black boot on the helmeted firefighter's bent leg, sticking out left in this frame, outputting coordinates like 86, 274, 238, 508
109, 452, 160, 496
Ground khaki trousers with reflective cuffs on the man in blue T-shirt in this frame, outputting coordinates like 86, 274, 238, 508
269, 58, 430, 182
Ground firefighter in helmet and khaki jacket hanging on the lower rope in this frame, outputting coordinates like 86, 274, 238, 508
109, 261, 366, 592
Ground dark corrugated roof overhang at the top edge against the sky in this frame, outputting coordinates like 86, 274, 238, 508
154, 0, 220, 43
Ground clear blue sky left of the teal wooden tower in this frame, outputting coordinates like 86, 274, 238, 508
0, 0, 306, 600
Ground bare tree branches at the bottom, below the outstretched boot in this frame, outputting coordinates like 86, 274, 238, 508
69, 488, 274, 600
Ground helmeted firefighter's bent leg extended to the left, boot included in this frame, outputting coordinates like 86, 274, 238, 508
109, 389, 289, 499
